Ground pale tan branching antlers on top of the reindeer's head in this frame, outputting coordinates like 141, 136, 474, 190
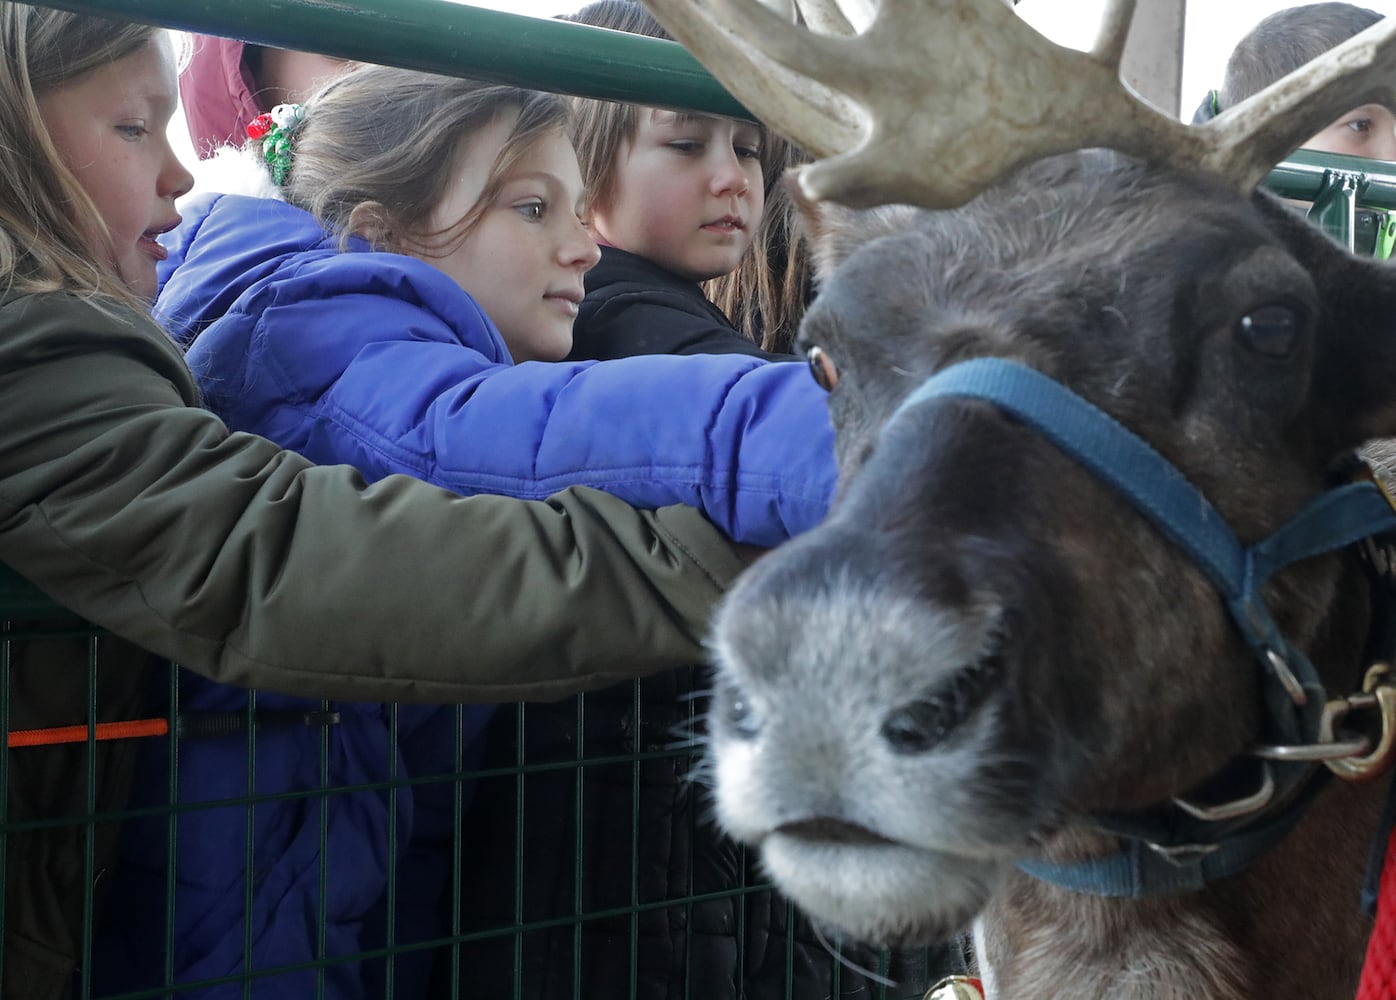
646, 0, 1396, 208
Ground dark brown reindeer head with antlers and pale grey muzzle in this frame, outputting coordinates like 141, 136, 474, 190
649, 0, 1396, 955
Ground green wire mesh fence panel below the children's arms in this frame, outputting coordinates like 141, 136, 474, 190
0, 606, 959, 1000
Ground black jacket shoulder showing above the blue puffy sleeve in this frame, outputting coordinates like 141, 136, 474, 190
567, 247, 790, 360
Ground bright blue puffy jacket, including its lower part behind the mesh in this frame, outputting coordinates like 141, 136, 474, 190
94, 196, 835, 1000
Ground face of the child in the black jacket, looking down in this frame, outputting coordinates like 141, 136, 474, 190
591, 108, 765, 281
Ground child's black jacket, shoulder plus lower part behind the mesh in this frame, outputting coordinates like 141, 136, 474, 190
463, 247, 962, 1000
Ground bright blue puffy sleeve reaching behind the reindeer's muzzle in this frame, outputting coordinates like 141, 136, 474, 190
190, 254, 835, 546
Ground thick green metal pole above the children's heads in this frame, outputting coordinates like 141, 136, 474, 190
32, 0, 752, 119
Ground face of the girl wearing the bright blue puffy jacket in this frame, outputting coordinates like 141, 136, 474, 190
416, 117, 600, 362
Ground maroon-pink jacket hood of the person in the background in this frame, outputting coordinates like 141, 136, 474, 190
179, 35, 262, 159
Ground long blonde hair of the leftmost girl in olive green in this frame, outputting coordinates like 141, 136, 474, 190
0, 1, 161, 309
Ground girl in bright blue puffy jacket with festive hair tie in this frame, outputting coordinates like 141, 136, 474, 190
96, 67, 835, 1000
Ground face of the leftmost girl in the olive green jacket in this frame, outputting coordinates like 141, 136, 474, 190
39, 39, 194, 299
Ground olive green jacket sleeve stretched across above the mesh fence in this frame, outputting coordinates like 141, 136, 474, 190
0, 295, 743, 701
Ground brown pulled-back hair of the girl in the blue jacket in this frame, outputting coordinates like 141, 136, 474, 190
286, 66, 571, 254
